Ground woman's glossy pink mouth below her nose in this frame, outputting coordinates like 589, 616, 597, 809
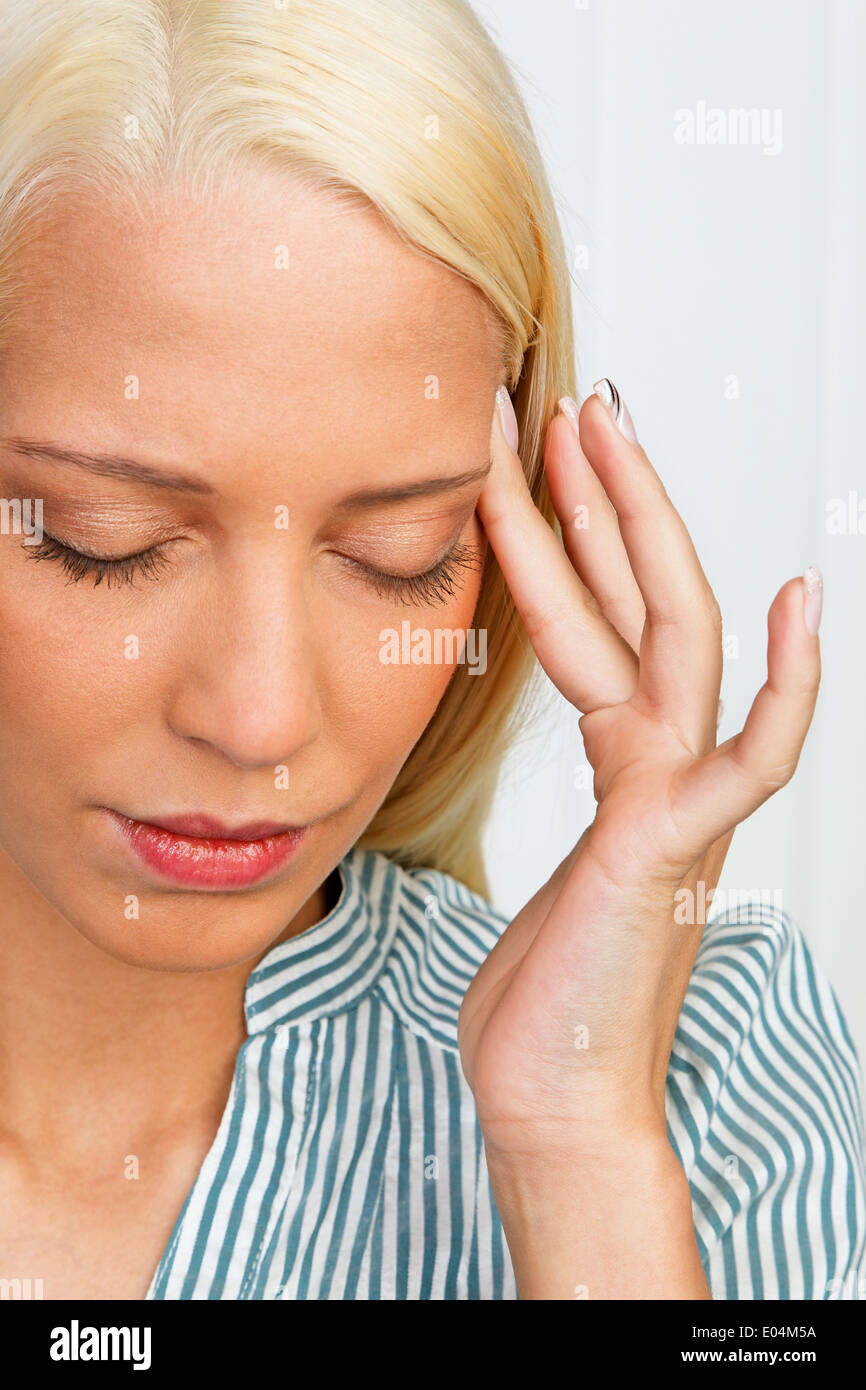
108, 810, 307, 890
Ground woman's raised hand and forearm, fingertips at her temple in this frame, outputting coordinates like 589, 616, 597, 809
460, 384, 820, 1297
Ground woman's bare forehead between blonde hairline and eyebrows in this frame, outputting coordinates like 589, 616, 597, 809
0, 168, 500, 469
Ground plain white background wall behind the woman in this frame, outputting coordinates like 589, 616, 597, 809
475, 0, 866, 1063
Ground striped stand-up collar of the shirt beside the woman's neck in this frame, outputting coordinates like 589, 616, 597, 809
243, 847, 399, 1036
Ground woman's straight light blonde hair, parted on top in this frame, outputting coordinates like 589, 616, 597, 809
0, 0, 575, 895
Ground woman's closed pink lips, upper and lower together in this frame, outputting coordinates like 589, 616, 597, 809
108, 810, 307, 890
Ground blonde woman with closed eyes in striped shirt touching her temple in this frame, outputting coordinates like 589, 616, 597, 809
0, 0, 866, 1300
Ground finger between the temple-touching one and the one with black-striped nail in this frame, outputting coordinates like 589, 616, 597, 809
545, 398, 645, 652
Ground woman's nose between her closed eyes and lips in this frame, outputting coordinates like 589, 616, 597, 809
168, 552, 322, 769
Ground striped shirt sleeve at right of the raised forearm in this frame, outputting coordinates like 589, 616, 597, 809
667, 906, 866, 1300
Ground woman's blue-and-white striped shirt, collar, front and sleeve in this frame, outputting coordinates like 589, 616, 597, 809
146, 848, 866, 1300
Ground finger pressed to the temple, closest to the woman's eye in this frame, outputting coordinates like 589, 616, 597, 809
478, 394, 638, 712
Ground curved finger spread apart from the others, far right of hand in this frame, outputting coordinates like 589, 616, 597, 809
673, 570, 822, 842
